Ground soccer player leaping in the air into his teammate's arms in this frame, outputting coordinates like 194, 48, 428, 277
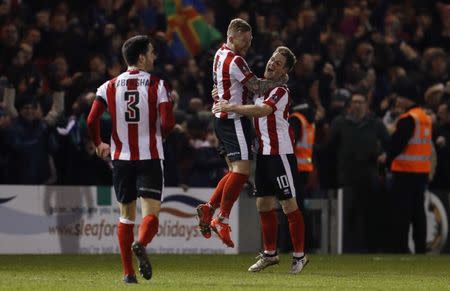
197, 18, 287, 247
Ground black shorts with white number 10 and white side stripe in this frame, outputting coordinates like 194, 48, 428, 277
255, 154, 298, 200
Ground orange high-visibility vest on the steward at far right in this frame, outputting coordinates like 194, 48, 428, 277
391, 107, 432, 174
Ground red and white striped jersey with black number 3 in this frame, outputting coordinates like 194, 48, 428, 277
97, 70, 171, 160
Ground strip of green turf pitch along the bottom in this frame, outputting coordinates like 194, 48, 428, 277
0, 255, 450, 290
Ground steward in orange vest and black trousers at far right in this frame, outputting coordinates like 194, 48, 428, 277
387, 77, 432, 253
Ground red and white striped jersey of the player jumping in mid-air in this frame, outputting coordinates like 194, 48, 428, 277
213, 44, 254, 119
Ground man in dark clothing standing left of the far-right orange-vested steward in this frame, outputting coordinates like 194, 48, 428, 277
328, 93, 389, 253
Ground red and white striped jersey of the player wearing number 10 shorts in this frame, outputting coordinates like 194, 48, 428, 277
254, 86, 294, 155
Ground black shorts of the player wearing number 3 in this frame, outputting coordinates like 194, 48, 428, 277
112, 160, 164, 204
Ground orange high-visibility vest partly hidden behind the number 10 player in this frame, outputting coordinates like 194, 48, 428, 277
289, 112, 315, 172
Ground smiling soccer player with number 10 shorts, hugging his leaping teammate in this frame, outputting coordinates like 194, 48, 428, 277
213, 47, 308, 274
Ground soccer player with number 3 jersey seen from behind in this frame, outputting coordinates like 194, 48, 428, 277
87, 35, 175, 283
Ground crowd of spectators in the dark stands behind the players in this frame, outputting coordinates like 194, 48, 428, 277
0, 0, 450, 194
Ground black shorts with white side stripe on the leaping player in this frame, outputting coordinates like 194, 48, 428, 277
214, 117, 253, 162
